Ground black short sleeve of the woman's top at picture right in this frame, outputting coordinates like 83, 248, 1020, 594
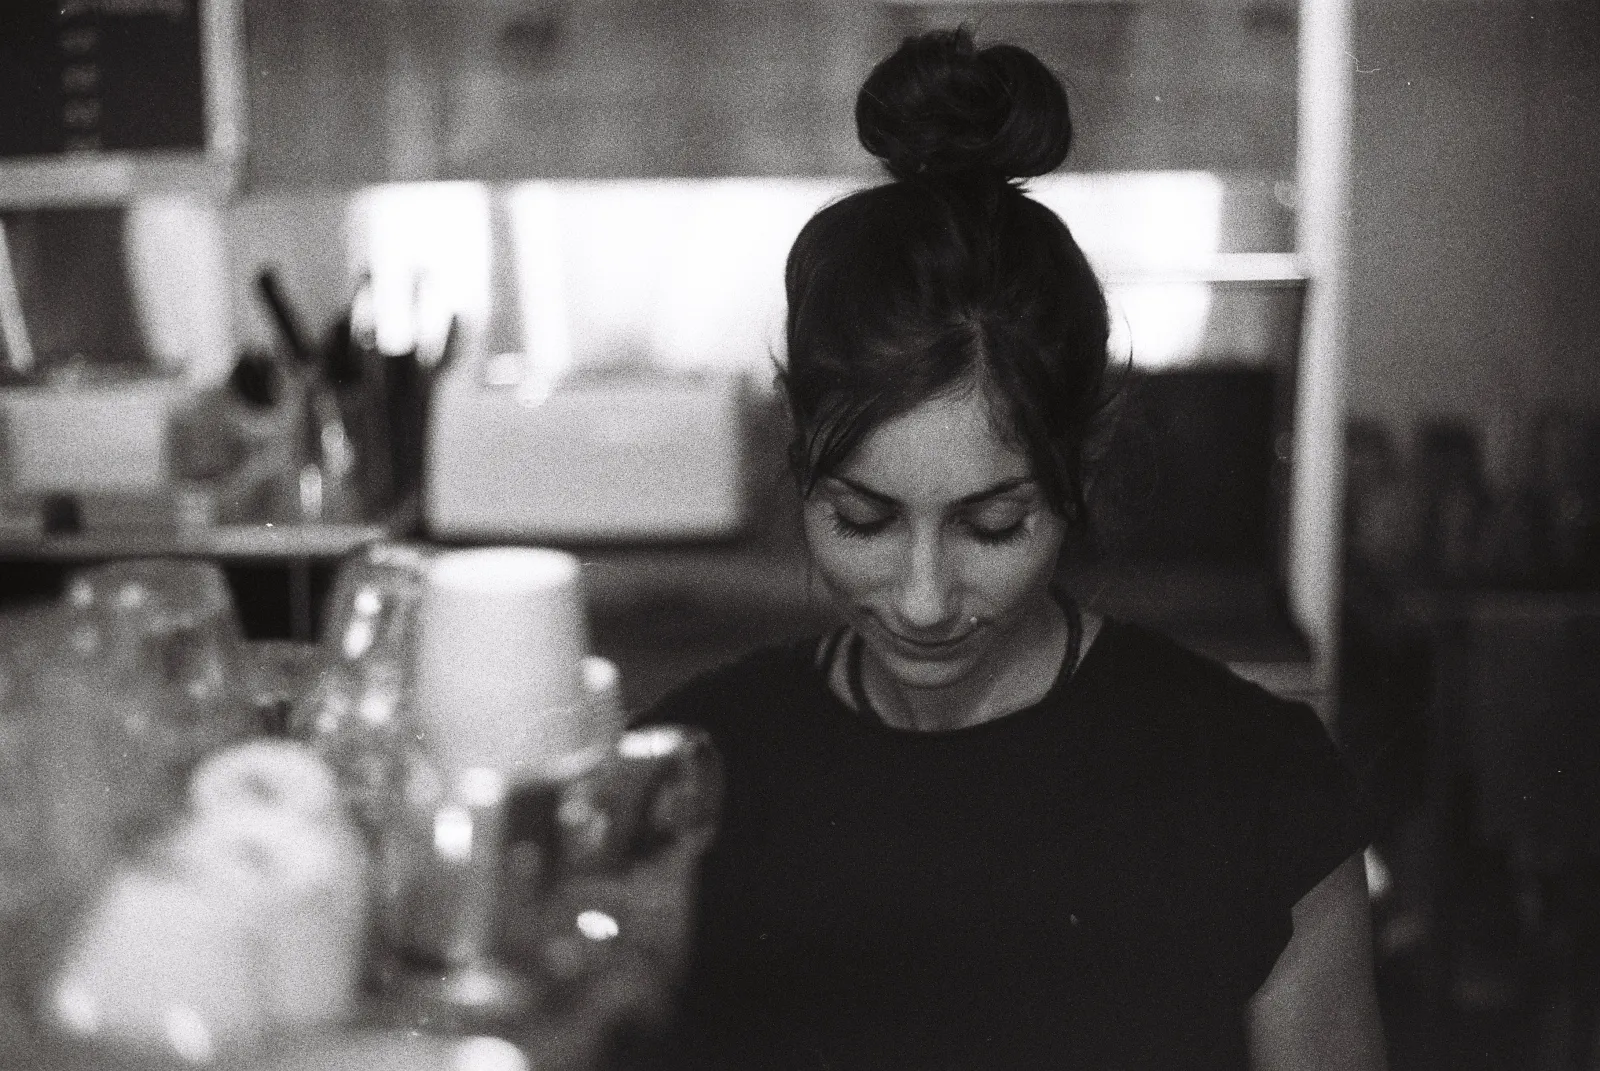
1261, 703, 1373, 911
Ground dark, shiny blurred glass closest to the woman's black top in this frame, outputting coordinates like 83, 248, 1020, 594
499, 725, 723, 1066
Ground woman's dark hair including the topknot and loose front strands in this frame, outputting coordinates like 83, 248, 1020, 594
781, 27, 1109, 525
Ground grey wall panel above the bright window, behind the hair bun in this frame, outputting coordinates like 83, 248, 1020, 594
246, 0, 1296, 189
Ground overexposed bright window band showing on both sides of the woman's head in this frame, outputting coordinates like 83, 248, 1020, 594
473, 171, 1222, 377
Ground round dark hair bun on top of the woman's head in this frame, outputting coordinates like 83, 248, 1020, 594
856, 27, 1072, 179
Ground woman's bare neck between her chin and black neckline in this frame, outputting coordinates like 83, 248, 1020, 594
861, 594, 1067, 732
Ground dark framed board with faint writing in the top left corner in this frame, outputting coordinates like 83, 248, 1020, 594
0, 0, 208, 158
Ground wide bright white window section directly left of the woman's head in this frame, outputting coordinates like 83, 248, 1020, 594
507, 179, 851, 384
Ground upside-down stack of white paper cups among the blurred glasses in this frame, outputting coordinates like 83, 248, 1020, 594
414, 548, 621, 780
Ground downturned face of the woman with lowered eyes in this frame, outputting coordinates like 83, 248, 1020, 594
803, 389, 1064, 688
